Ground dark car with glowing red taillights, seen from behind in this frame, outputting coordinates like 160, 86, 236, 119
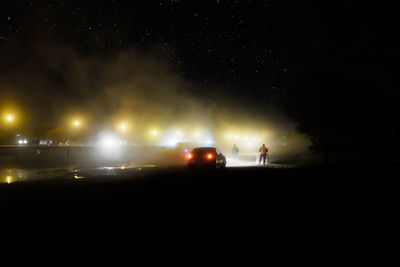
187, 147, 226, 168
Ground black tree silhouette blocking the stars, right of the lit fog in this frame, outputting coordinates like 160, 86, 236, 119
284, 1, 400, 164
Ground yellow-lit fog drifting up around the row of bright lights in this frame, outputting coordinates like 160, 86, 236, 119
0, 40, 308, 159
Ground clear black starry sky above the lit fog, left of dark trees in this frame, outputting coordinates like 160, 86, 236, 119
0, 0, 310, 103
